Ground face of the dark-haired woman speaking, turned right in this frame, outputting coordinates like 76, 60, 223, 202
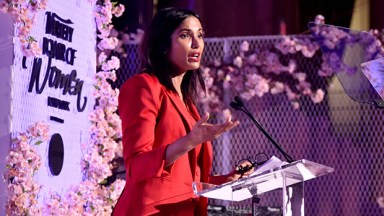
168, 16, 204, 75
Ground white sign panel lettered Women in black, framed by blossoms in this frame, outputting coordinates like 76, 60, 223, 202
0, 0, 96, 212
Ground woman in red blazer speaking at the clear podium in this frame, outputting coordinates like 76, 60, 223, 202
114, 8, 249, 215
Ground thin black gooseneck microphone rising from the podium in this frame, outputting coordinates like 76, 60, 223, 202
229, 96, 294, 163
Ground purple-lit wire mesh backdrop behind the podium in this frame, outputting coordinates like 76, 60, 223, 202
115, 38, 384, 216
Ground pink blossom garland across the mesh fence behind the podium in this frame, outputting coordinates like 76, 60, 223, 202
200, 19, 384, 112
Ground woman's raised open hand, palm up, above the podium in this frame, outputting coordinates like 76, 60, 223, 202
188, 113, 239, 145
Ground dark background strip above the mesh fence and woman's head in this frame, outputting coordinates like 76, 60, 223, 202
114, 0, 384, 37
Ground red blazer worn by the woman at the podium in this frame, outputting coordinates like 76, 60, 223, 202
113, 73, 212, 216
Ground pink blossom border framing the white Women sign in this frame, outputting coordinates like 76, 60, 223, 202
1, 0, 125, 215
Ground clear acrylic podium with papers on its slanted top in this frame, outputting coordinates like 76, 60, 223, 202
192, 159, 334, 216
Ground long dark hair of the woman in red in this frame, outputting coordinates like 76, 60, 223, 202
141, 8, 205, 104
